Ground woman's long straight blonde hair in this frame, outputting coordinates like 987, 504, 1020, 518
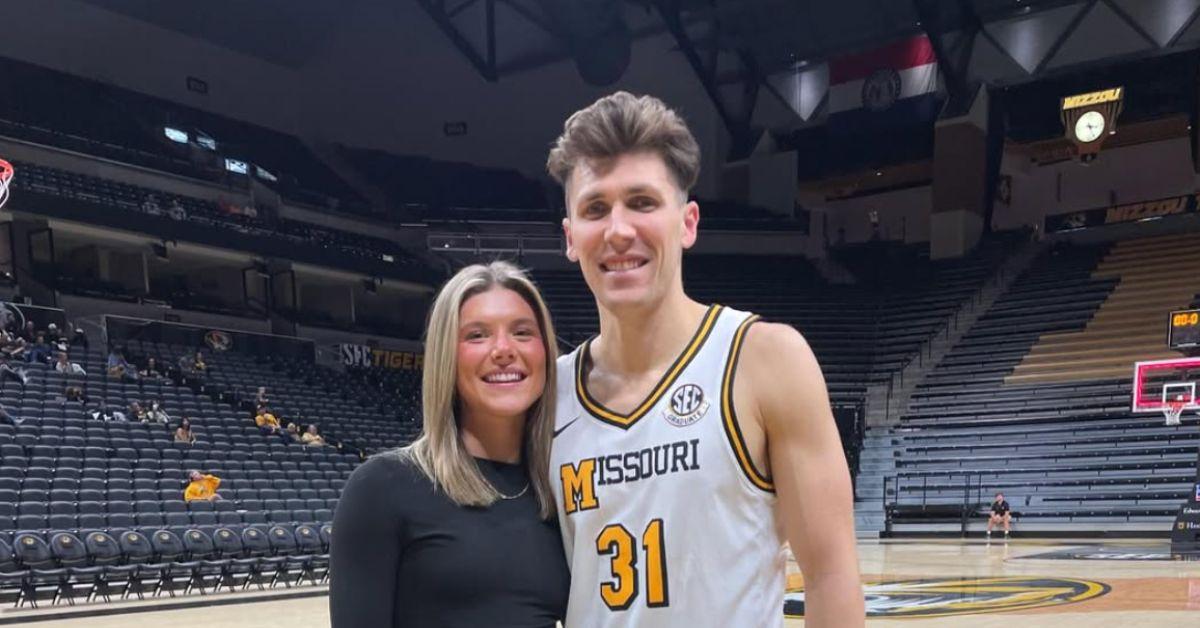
396, 262, 558, 519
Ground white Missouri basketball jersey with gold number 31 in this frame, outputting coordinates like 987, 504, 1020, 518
551, 305, 786, 628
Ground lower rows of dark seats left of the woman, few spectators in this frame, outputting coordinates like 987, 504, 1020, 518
0, 333, 357, 603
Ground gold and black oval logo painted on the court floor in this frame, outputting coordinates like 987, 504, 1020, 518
784, 576, 1111, 617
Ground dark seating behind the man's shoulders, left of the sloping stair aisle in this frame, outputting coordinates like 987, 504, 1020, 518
536, 234, 1022, 405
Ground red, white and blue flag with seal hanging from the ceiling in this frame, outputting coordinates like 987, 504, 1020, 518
829, 35, 941, 131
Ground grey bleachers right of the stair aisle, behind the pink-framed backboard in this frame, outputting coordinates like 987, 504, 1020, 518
857, 235, 1200, 533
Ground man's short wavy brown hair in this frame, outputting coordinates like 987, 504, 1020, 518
546, 91, 700, 198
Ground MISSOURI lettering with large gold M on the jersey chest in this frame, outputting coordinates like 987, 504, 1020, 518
558, 438, 700, 514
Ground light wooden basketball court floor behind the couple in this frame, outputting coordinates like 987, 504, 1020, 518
14, 539, 1200, 628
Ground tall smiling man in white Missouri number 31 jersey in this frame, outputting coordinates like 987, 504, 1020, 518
547, 92, 864, 628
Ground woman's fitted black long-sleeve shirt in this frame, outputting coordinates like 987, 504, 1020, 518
329, 455, 570, 628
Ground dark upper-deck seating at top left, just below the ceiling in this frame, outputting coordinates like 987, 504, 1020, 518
0, 53, 364, 210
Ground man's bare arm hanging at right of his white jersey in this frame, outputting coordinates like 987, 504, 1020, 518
739, 323, 865, 628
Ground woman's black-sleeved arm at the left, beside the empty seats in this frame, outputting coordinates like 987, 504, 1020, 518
329, 457, 404, 628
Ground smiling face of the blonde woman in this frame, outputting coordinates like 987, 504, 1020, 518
457, 287, 546, 420
